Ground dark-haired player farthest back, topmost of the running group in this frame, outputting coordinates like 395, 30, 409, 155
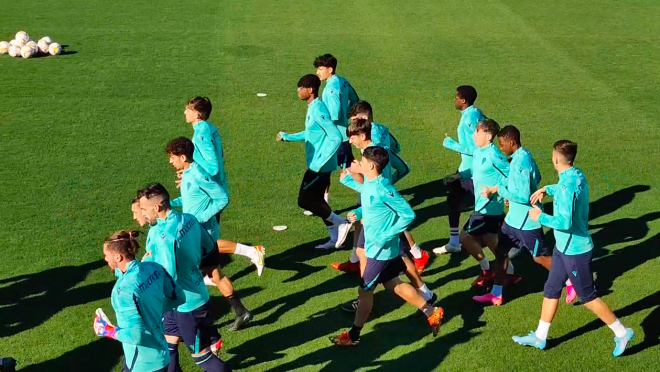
314, 54, 359, 206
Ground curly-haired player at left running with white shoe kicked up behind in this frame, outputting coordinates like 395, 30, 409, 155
166, 137, 264, 330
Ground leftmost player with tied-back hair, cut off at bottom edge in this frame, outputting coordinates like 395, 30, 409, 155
94, 231, 185, 372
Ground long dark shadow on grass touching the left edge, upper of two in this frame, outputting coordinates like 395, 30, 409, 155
0, 260, 114, 337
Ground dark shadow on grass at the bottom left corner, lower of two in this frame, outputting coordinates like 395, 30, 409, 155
18, 338, 123, 372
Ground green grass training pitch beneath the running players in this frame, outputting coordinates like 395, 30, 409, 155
0, 0, 660, 372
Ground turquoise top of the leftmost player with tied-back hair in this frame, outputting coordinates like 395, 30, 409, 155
110, 261, 185, 372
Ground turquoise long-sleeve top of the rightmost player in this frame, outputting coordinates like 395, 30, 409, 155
539, 167, 594, 256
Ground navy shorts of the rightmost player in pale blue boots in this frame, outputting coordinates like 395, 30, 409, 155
543, 248, 598, 304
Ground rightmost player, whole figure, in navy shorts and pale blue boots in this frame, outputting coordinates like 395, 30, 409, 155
513, 140, 634, 357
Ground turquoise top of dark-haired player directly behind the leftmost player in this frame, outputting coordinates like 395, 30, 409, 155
146, 210, 215, 312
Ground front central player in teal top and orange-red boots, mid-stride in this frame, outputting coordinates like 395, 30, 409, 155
330, 147, 443, 346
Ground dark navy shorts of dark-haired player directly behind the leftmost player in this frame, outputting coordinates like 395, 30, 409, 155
163, 302, 220, 354
